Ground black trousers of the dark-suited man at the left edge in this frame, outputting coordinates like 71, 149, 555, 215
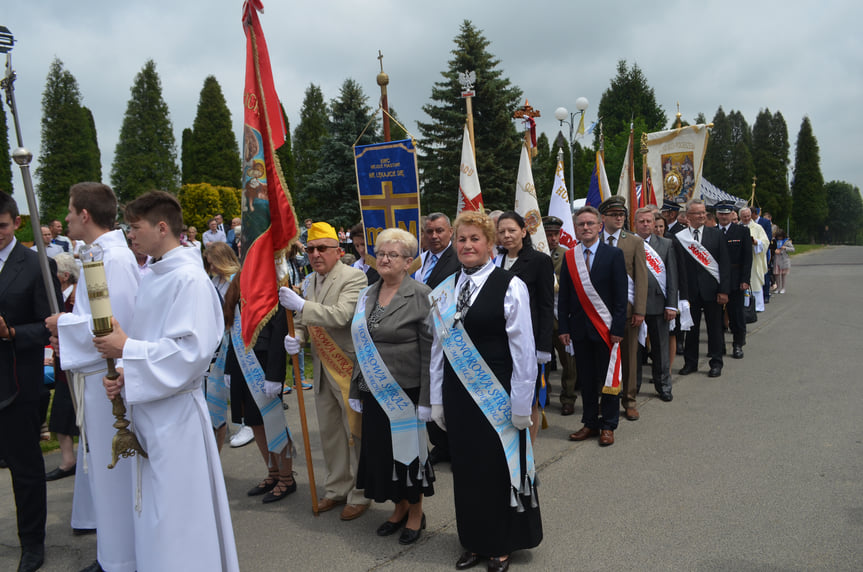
0, 396, 47, 546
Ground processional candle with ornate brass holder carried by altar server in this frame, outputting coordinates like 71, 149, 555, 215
79, 244, 147, 469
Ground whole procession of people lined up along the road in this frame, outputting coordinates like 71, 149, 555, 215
0, 183, 794, 571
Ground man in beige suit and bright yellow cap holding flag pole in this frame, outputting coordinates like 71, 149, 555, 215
279, 222, 370, 520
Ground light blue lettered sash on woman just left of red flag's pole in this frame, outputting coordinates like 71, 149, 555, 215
231, 305, 294, 457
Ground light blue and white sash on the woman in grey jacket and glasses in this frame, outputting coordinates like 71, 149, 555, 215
351, 286, 428, 486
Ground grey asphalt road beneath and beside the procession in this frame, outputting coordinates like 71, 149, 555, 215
0, 247, 863, 572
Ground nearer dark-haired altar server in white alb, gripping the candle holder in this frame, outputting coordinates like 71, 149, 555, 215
95, 191, 239, 572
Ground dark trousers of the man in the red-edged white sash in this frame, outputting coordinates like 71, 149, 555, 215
572, 340, 623, 431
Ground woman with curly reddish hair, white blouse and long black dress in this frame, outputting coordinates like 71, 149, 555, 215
431, 212, 542, 571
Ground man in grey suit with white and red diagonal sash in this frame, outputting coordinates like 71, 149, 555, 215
635, 208, 677, 401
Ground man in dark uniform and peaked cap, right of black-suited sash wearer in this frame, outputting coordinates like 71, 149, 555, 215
716, 201, 752, 359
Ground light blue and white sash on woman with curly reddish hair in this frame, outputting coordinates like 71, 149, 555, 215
429, 278, 537, 512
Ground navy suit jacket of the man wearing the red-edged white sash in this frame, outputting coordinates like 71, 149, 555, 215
557, 242, 629, 342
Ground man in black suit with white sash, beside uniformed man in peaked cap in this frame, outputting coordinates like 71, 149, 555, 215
675, 199, 731, 377
